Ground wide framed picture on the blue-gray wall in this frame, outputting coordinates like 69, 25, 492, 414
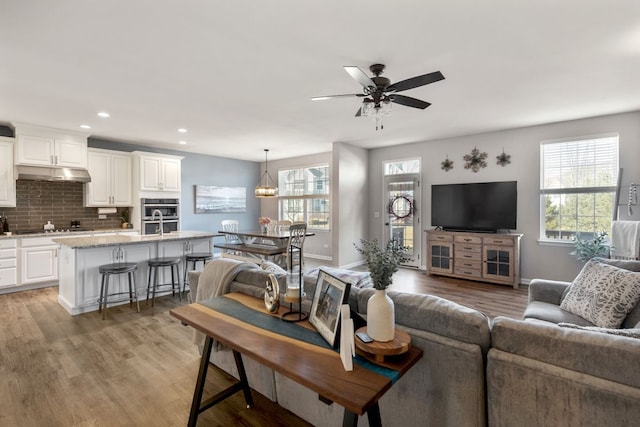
195, 185, 247, 213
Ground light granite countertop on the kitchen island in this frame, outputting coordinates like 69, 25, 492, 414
53, 231, 221, 249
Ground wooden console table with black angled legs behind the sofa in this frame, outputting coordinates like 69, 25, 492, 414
170, 294, 422, 426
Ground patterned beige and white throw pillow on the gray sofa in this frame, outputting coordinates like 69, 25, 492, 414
560, 260, 640, 328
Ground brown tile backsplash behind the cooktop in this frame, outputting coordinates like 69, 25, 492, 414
0, 180, 129, 232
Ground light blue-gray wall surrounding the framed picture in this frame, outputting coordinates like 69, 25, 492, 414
89, 138, 260, 231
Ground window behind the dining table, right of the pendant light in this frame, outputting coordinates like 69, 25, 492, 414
278, 165, 330, 230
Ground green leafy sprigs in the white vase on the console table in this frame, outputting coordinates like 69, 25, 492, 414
353, 239, 409, 290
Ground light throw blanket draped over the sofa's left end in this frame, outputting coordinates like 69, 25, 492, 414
193, 258, 260, 353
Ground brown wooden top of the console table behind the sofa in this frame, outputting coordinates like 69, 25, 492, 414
170, 294, 422, 415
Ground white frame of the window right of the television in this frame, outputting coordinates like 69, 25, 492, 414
538, 133, 620, 245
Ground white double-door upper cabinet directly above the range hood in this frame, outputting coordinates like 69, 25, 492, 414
15, 125, 87, 169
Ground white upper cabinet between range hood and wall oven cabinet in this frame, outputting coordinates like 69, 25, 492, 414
85, 148, 132, 206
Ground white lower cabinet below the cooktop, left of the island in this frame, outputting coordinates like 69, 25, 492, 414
20, 238, 58, 285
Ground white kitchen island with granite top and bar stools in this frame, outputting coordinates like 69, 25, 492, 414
53, 231, 220, 315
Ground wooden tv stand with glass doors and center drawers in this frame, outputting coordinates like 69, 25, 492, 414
426, 230, 522, 289
